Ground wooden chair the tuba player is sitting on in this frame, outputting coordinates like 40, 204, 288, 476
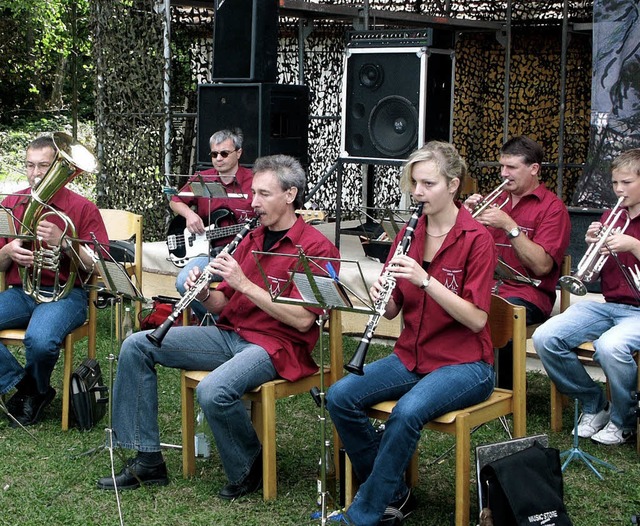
0, 272, 97, 431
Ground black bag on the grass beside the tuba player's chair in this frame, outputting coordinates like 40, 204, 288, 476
71, 358, 109, 431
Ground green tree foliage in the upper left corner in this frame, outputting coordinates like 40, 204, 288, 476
0, 0, 93, 123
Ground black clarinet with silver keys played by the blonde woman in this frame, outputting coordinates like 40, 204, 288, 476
344, 203, 424, 376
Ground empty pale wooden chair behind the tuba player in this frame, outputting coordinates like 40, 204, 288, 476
100, 208, 142, 332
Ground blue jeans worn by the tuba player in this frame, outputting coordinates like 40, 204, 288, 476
0, 287, 87, 394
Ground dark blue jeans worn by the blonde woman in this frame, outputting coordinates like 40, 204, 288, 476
327, 354, 494, 526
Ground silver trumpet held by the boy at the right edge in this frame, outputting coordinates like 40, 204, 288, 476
558, 196, 631, 296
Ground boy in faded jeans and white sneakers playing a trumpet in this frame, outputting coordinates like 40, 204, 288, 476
533, 148, 640, 445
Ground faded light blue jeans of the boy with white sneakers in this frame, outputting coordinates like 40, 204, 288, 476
533, 301, 640, 431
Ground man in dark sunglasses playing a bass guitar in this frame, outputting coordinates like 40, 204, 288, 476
167, 128, 254, 319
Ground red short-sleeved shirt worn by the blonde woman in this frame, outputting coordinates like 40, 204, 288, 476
389, 207, 496, 374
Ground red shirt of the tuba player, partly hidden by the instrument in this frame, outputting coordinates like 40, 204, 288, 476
0, 188, 109, 287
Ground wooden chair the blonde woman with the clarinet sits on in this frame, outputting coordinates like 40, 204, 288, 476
345, 295, 527, 526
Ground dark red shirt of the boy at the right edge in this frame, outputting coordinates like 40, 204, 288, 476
600, 206, 640, 306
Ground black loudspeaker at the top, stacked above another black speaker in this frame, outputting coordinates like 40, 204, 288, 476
213, 0, 278, 82
